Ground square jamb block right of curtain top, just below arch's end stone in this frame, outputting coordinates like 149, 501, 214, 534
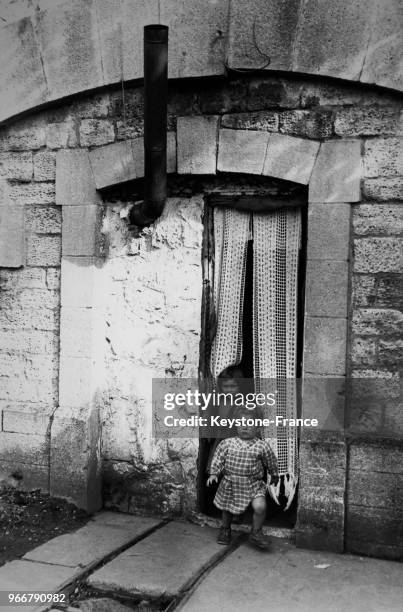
307, 203, 351, 261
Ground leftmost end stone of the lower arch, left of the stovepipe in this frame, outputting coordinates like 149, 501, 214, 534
56, 149, 101, 206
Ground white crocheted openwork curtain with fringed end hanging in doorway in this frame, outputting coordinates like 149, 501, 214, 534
211, 207, 301, 510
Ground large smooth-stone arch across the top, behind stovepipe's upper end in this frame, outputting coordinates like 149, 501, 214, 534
0, 0, 402, 121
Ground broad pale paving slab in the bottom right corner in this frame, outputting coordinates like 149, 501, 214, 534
178, 541, 403, 612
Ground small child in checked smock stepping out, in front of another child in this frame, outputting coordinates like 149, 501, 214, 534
207, 410, 278, 549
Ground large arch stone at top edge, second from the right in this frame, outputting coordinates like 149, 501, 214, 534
292, 0, 372, 81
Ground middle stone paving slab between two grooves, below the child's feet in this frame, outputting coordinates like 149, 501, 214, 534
87, 522, 226, 598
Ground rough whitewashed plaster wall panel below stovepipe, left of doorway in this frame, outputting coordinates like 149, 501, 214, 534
101, 196, 203, 514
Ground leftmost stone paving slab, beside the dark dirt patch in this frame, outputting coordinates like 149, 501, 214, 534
23, 513, 161, 567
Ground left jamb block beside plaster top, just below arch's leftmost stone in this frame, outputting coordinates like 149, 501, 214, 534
62, 204, 102, 257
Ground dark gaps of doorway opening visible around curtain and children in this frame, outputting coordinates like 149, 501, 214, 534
198, 206, 307, 528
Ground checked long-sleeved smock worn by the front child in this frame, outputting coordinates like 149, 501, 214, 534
209, 438, 277, 514
